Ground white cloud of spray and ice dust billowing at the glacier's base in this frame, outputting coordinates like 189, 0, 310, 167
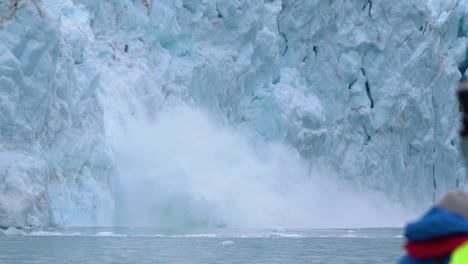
115, 107, 414, 228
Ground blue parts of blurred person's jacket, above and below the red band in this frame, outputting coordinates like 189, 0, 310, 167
399, 206, 468, 264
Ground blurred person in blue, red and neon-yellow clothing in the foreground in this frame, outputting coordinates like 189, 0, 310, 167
399, 191, 468, 264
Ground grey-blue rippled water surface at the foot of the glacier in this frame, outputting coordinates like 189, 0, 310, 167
0, 228, 404, 264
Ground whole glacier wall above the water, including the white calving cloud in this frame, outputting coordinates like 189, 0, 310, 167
0, 0, 468, 227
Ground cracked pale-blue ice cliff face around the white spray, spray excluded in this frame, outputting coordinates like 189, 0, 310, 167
0, 0, 468, 226
